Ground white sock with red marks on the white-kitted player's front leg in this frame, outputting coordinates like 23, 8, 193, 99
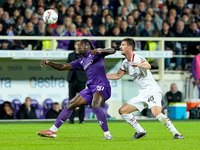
121, 114, 144, 133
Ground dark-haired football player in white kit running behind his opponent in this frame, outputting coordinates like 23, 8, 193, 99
107, 38, 184, 139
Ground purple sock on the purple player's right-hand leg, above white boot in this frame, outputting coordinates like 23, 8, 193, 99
94, 108, 108, 132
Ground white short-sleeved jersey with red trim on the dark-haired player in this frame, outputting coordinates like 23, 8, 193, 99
120, 53, 161, 95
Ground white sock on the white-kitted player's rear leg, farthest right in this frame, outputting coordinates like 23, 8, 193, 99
156, 113, 180, 135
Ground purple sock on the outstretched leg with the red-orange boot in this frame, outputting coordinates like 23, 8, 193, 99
54, 106, 73, 128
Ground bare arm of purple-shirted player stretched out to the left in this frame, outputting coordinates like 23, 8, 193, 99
40, 59, 72, 71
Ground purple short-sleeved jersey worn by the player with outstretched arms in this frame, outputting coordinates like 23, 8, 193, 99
70, 52, 110, 87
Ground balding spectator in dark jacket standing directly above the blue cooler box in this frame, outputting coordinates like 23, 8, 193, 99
174, 20, 188, 70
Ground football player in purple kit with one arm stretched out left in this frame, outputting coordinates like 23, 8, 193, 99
37, 39, 115, 140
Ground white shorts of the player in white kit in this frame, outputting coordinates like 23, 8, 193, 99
127, 92, 162, 112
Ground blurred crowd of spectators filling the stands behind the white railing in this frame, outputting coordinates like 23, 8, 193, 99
0, 0, 200, 69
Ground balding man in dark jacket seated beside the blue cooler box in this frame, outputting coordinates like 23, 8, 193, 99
163, 83, 184, 114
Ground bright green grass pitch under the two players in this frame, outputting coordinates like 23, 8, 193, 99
0, 120, 200, 150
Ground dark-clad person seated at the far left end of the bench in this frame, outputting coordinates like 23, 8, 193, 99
0, 101, 14, 119
